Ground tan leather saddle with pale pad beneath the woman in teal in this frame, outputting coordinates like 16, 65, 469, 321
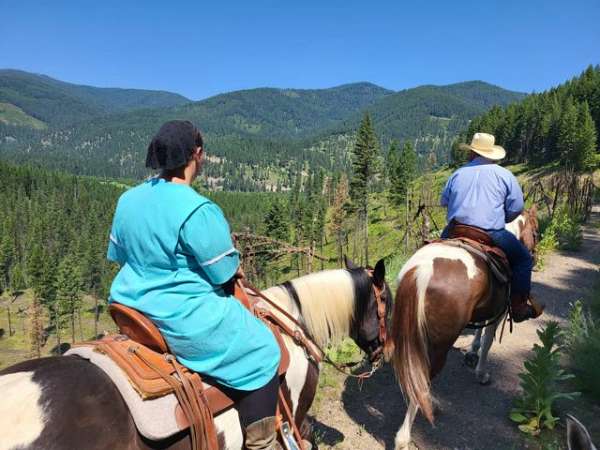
65, 284, 290, 440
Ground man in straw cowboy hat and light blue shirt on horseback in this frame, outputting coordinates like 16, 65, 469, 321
441, 133, 539, 322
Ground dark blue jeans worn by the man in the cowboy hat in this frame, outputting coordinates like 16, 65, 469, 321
441, 226, 533, 294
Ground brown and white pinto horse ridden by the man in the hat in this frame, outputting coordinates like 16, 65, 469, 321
391, 207, 538, 450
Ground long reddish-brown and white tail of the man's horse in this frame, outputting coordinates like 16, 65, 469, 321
391, 267, 433, 423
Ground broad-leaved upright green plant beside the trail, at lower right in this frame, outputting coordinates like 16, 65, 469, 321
510, 322, 578, 436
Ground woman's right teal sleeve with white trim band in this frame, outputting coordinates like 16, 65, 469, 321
179, 203, 241, 285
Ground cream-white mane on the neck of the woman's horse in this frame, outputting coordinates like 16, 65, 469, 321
264, 269, 355, 346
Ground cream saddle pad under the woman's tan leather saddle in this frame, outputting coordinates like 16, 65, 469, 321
65, 346, 184, 441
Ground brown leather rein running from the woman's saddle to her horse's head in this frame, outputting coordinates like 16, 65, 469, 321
236, 269, 387, 381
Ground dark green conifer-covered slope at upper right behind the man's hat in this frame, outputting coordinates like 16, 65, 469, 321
454, 66, 600, 171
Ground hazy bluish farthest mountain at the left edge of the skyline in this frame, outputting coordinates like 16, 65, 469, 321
0, 69, 190, 127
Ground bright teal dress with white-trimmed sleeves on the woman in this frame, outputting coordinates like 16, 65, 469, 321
108, 178, 280, 390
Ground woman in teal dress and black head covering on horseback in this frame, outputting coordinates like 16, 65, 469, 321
108, 121, 280, 449
